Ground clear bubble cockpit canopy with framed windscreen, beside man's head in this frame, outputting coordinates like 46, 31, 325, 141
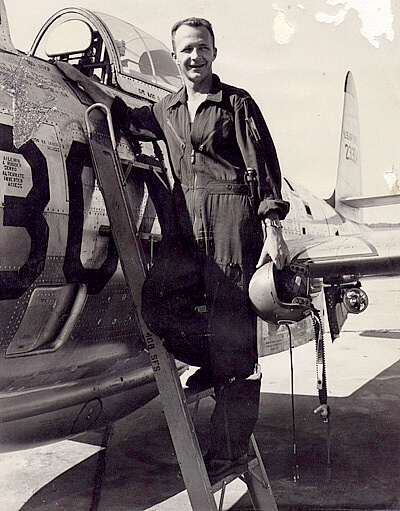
31, 8, 181, 100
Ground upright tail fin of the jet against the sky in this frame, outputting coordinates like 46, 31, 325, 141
327, 71, 363, 223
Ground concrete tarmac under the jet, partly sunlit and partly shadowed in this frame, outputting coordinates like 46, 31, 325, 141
0, 278, 400, 511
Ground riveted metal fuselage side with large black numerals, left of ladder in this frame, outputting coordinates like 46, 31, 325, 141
0, 54, 166, 450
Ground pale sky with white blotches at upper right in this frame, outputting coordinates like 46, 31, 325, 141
4, 0, 400, 222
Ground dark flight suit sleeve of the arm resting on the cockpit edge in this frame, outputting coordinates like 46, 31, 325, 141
111, 96, 164, 141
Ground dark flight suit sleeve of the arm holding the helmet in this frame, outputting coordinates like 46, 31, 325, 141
235, 97, 290, 220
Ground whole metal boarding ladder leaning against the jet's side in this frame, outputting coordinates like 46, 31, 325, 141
85, 103, 277, 511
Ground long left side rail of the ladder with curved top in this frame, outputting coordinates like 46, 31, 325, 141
86, 103, 217, 511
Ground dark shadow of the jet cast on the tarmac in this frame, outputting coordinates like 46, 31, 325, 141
23, 360, 400, 511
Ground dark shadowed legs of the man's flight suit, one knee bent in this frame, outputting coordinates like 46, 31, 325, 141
142, 238, 260, 459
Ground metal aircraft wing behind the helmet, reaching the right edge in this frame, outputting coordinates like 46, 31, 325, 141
288, 229, 400, 283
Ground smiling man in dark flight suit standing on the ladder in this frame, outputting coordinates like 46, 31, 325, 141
59, 18, 289, 477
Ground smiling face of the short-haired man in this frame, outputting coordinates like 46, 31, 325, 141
173, 25, 217, 83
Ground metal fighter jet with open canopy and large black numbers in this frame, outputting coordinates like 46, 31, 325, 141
0, 0, 400, 451
